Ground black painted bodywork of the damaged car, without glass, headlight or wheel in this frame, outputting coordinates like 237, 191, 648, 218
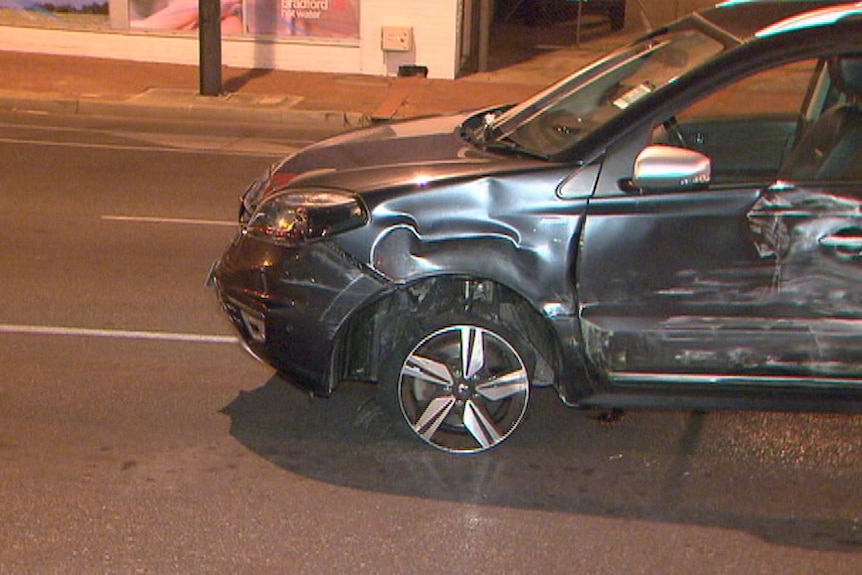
215, 4, 862, 409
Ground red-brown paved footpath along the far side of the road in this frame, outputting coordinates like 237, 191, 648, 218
0, 27, 637, 126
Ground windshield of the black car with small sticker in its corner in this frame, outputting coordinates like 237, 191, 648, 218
486, 30, 725, 157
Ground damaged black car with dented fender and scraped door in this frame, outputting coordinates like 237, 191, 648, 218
210, 1, 862, 453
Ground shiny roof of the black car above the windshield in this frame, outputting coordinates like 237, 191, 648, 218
698, 0, 862, 42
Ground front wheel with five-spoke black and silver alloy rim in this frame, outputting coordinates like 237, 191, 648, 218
384, 323, 530, 453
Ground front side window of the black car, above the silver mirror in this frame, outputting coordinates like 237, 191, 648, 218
653, 59, 821, 183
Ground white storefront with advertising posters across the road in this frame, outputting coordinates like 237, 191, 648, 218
0, 0, 706, 78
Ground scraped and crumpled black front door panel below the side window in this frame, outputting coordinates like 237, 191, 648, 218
578, 176, 862, 386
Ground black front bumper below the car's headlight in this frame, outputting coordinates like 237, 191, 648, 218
209, 234, 386, 395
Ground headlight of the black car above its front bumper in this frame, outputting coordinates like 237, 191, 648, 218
244, 190, 368, 245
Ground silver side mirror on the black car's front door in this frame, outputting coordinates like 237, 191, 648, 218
632, 144, 712, 191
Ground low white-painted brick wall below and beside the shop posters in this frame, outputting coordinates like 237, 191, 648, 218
0, 0, 460, 78
